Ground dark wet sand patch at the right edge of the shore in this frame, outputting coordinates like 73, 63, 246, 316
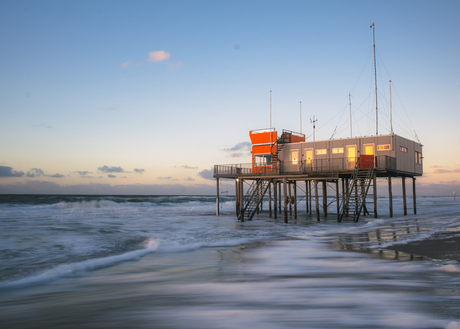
386, 233, 460, 263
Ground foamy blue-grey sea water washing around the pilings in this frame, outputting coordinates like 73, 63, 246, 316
0, 195, 460, 329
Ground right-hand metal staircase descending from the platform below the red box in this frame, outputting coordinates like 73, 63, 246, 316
337, 158, 375, 223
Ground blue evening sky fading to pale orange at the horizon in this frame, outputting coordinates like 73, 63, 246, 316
0, 0, 460, 195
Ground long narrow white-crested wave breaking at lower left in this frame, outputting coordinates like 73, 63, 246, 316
0, 238, 159, 289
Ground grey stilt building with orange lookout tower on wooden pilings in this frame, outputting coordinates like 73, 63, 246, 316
214, 128, 423, 222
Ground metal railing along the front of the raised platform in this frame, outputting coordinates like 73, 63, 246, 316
214, 155, 396, 176
